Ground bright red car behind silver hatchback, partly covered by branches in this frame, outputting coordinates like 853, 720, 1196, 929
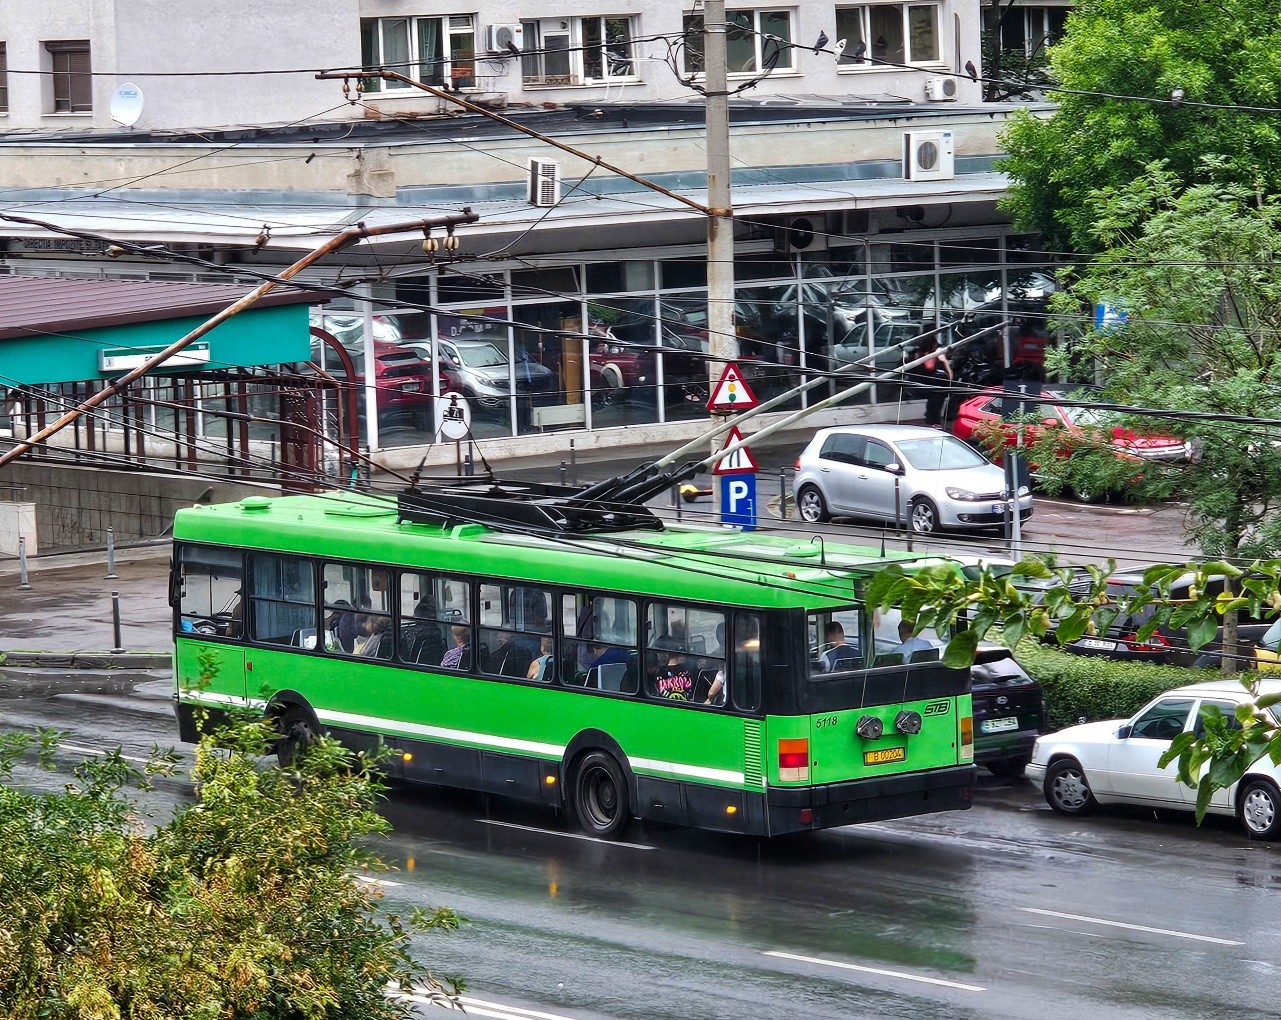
952, 387, 1193, 502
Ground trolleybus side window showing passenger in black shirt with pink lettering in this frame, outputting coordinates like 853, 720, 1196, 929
646, 602, 725, 705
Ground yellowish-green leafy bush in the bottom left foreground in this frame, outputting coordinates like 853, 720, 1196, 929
0, 725, 460, 1020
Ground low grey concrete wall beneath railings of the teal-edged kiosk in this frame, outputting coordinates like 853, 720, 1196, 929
0, 459, 273, 557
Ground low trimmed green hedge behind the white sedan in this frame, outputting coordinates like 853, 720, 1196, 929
1015, 638, 1223, 733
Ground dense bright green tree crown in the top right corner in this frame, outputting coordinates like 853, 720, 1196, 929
1000, 0, 1281, 252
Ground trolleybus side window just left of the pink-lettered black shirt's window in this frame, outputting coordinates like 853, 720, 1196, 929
557, 592, 641, 695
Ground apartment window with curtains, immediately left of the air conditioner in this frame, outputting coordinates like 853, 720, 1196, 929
360, 14, 477, 92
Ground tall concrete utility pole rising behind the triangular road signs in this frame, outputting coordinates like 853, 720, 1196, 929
703, 0, 738, 514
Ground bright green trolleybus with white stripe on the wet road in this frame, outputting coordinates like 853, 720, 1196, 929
170, 483, 975, 837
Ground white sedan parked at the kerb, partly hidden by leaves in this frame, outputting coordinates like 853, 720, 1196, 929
1026, 679, 1281, 839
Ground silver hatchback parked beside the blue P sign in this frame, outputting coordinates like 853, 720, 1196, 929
792, 425, 1032, 534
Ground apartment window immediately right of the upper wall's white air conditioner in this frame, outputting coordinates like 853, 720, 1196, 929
520, 17, 635, 85
